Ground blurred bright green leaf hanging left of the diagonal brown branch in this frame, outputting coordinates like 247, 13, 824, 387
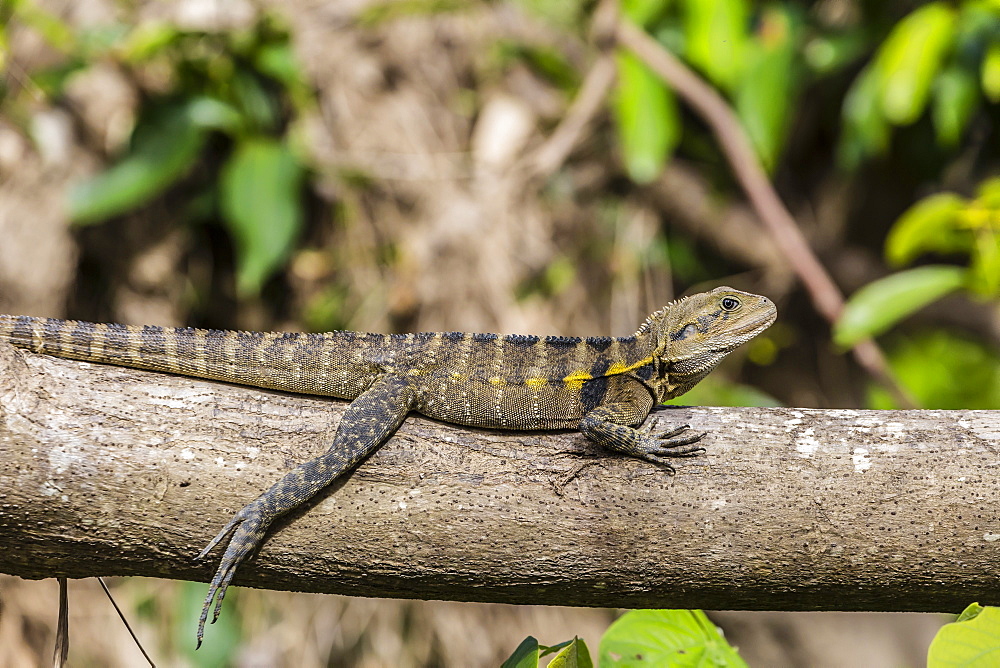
615, 52, 680, 183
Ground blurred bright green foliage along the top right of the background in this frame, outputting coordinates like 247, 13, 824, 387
616, 0, 1000, 177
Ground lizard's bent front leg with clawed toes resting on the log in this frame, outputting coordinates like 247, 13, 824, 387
580, 379, 705, 474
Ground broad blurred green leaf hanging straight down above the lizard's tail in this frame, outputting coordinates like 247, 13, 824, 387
220, 138, 303, 296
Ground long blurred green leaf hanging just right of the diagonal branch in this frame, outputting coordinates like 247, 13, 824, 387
736, 7, 796, 171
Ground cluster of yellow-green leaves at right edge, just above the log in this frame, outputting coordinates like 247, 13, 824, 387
834, 178, 1000, 409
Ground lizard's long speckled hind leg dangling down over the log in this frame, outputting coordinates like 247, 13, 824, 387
197, 376, 416, 647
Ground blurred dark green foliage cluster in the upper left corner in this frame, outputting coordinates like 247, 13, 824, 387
1, 1, 314, 298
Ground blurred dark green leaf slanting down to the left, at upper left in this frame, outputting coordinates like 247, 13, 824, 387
68, 104, 206, 225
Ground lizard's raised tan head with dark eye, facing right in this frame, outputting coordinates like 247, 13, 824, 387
636, 287, 778, 399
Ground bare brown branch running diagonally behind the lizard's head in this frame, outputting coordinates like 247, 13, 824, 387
615, 20, 915, 407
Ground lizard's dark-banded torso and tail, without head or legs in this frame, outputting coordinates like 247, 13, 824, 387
0, 316, 664, 429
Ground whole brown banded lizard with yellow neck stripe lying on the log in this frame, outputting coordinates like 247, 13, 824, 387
0, 288, 777, 645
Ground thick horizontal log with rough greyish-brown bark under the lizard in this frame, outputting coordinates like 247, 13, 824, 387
0, 345, 1000, 611
